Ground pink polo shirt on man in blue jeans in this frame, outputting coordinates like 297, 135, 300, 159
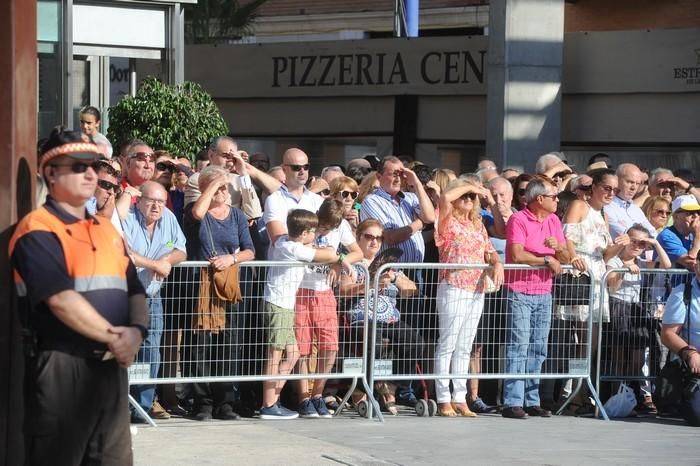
505, 208, 566, 295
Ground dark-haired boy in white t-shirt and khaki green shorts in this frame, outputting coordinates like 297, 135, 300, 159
260, 209, 339, 419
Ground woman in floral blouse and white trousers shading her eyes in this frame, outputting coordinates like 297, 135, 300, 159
435, 180, 503, 417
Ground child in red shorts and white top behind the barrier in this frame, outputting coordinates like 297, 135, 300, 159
296, 199, 362, 418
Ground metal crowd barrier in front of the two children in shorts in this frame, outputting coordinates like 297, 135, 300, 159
124, 261, 381, 426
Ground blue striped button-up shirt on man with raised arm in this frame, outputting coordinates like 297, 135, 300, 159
360, 188, 425, 262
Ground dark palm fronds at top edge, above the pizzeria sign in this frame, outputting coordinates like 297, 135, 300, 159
184, 0, 267, 44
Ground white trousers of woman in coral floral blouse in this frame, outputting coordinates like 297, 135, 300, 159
435, 281, 484, 403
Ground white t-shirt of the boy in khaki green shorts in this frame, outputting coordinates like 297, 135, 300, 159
264, 235, 316, 309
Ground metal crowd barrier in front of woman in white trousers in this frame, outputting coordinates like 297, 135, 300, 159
369, 263, 608, 419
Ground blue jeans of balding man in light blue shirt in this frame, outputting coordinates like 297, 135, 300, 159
129, 296, 163, 412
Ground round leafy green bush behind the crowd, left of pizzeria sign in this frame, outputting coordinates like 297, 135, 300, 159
107, 76, 229, 158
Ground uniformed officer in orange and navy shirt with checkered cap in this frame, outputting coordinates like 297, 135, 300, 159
9, 128, 148, 465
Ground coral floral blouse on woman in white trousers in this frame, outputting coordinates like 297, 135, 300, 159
435, 216, 496, 293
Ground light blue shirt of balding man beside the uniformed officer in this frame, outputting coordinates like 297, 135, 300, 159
123, 206, 187, 297
